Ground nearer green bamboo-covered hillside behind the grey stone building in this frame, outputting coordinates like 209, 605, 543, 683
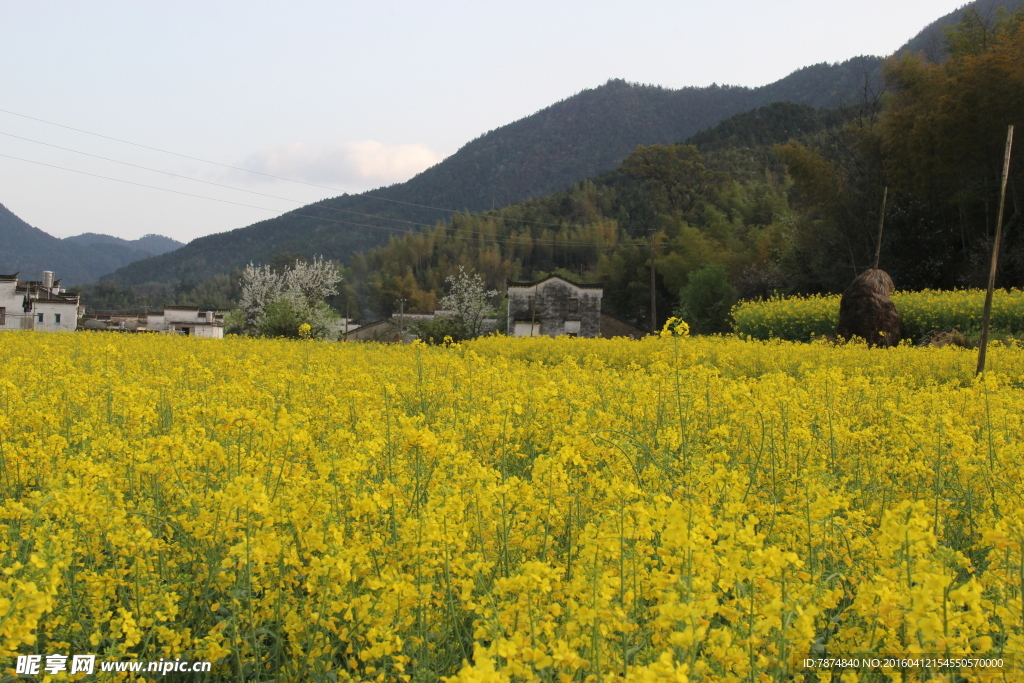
79, 102, 864, 327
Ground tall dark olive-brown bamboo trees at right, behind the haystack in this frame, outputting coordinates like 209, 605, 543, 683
777, 9, 1024, 289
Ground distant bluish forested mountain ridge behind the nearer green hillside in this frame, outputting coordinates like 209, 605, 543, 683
105, 57, 879, 285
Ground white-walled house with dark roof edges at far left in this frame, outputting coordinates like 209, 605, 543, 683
0, 270, 79, 332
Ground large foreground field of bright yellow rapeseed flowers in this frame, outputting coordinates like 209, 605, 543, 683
0, 333, 1024, 682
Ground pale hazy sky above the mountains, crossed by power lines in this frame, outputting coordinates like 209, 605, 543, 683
0, 0, 963, 241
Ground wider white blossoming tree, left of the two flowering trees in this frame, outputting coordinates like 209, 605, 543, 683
239, 257, 341, 338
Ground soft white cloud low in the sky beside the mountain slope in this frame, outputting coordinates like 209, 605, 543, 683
241, 140, 441, 190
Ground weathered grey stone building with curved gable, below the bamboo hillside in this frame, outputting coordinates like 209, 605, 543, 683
508, 275, 604, 337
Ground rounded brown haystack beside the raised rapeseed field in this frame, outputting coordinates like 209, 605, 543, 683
836, 268, 899, 346
